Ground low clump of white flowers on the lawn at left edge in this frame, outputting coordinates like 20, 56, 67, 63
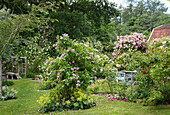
0, 86, 17, 101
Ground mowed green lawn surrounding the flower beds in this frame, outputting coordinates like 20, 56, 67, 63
0, 79, 170, 115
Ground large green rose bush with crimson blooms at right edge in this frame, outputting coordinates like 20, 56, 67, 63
127, 37, 170, 105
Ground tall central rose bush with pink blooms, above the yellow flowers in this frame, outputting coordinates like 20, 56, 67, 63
42, 34, 98, 91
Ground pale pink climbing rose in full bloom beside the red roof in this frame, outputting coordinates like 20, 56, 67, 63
112, 33, 147, 70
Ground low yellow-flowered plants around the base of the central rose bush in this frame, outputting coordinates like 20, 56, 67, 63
37, 90, 96, 113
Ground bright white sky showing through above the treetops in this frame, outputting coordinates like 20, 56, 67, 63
109, 0, 170, 14
